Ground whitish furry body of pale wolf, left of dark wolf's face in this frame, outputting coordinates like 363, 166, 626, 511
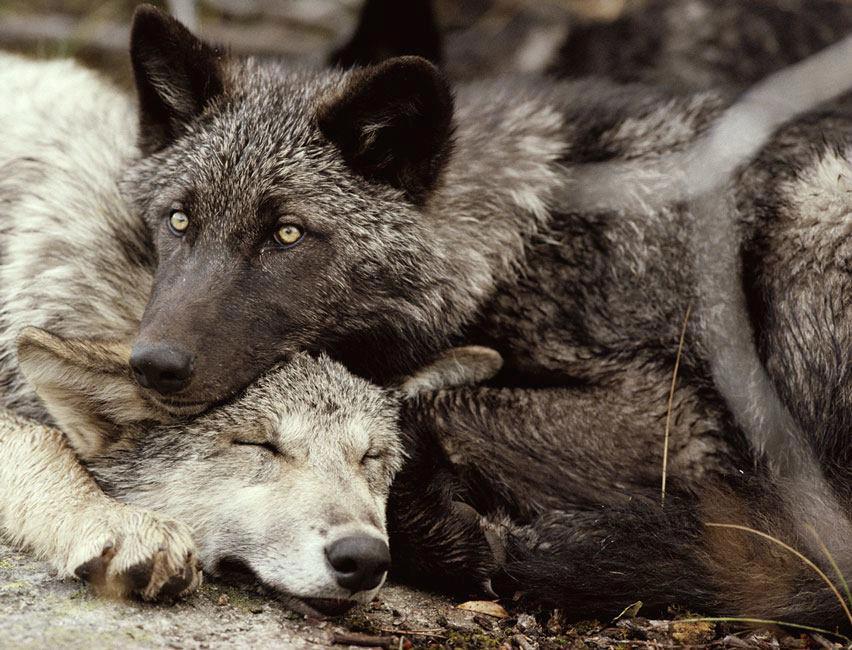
0, 53, 153, 417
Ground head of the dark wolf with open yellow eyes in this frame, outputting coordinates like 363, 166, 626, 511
122, 8, 458, 408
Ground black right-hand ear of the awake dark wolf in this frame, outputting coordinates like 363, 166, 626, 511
317, 56, 453, 203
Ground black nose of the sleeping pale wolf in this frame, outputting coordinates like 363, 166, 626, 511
325, 535, 390, 593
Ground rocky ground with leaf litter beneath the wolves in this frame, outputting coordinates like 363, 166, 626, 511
0, 544, 852, 650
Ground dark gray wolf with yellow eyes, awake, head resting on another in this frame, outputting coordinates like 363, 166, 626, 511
1, 3, 848, 619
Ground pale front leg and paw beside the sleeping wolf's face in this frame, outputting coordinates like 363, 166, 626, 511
0, 410, 201, 600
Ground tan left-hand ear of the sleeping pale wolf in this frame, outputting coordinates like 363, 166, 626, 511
17, 327, 169, 459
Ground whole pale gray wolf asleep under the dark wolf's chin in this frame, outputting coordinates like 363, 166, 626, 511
0, 55, 499, 613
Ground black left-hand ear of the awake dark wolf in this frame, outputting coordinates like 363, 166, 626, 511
130, 5, 224, 153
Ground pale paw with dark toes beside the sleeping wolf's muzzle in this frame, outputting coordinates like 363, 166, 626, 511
74, 507, 202, 600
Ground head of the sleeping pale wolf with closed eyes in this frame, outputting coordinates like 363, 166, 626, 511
18, 329, 500, 614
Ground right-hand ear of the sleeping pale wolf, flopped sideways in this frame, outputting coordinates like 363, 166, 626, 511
399, 345, 503, 397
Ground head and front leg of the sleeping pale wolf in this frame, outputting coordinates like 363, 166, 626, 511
6, 326, 499, 614
